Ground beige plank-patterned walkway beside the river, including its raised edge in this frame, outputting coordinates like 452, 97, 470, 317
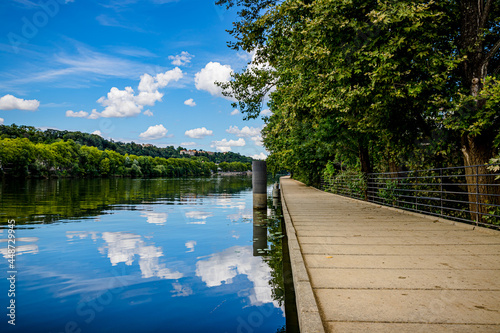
281, 177, 500, 333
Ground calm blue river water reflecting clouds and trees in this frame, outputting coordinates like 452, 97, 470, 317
0, 177, 285, 333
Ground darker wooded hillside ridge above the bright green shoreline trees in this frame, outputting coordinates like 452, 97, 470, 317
0, 124, 252, 163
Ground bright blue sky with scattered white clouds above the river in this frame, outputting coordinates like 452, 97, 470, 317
0, 0, 270, 158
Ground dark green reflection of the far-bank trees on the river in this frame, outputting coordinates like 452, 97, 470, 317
0, 177, 252, 225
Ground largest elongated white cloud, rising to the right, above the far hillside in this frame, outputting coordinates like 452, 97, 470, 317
89, 67, 183, 119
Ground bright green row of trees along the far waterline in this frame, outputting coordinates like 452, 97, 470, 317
0, 127, 251, 178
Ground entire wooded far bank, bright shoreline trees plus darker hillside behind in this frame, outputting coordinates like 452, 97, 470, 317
0, 125, 252, 178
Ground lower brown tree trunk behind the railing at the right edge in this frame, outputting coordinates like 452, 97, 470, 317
461, 134, 500, 222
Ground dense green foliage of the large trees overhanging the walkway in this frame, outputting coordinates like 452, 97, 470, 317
217, 0, 500, 184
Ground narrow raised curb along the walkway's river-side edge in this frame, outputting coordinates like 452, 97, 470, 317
280, 175, 325, 333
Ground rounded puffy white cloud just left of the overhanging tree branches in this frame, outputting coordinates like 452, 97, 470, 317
194, 62, 233, 97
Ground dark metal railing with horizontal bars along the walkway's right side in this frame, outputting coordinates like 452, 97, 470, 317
321, 164, 500, 229
